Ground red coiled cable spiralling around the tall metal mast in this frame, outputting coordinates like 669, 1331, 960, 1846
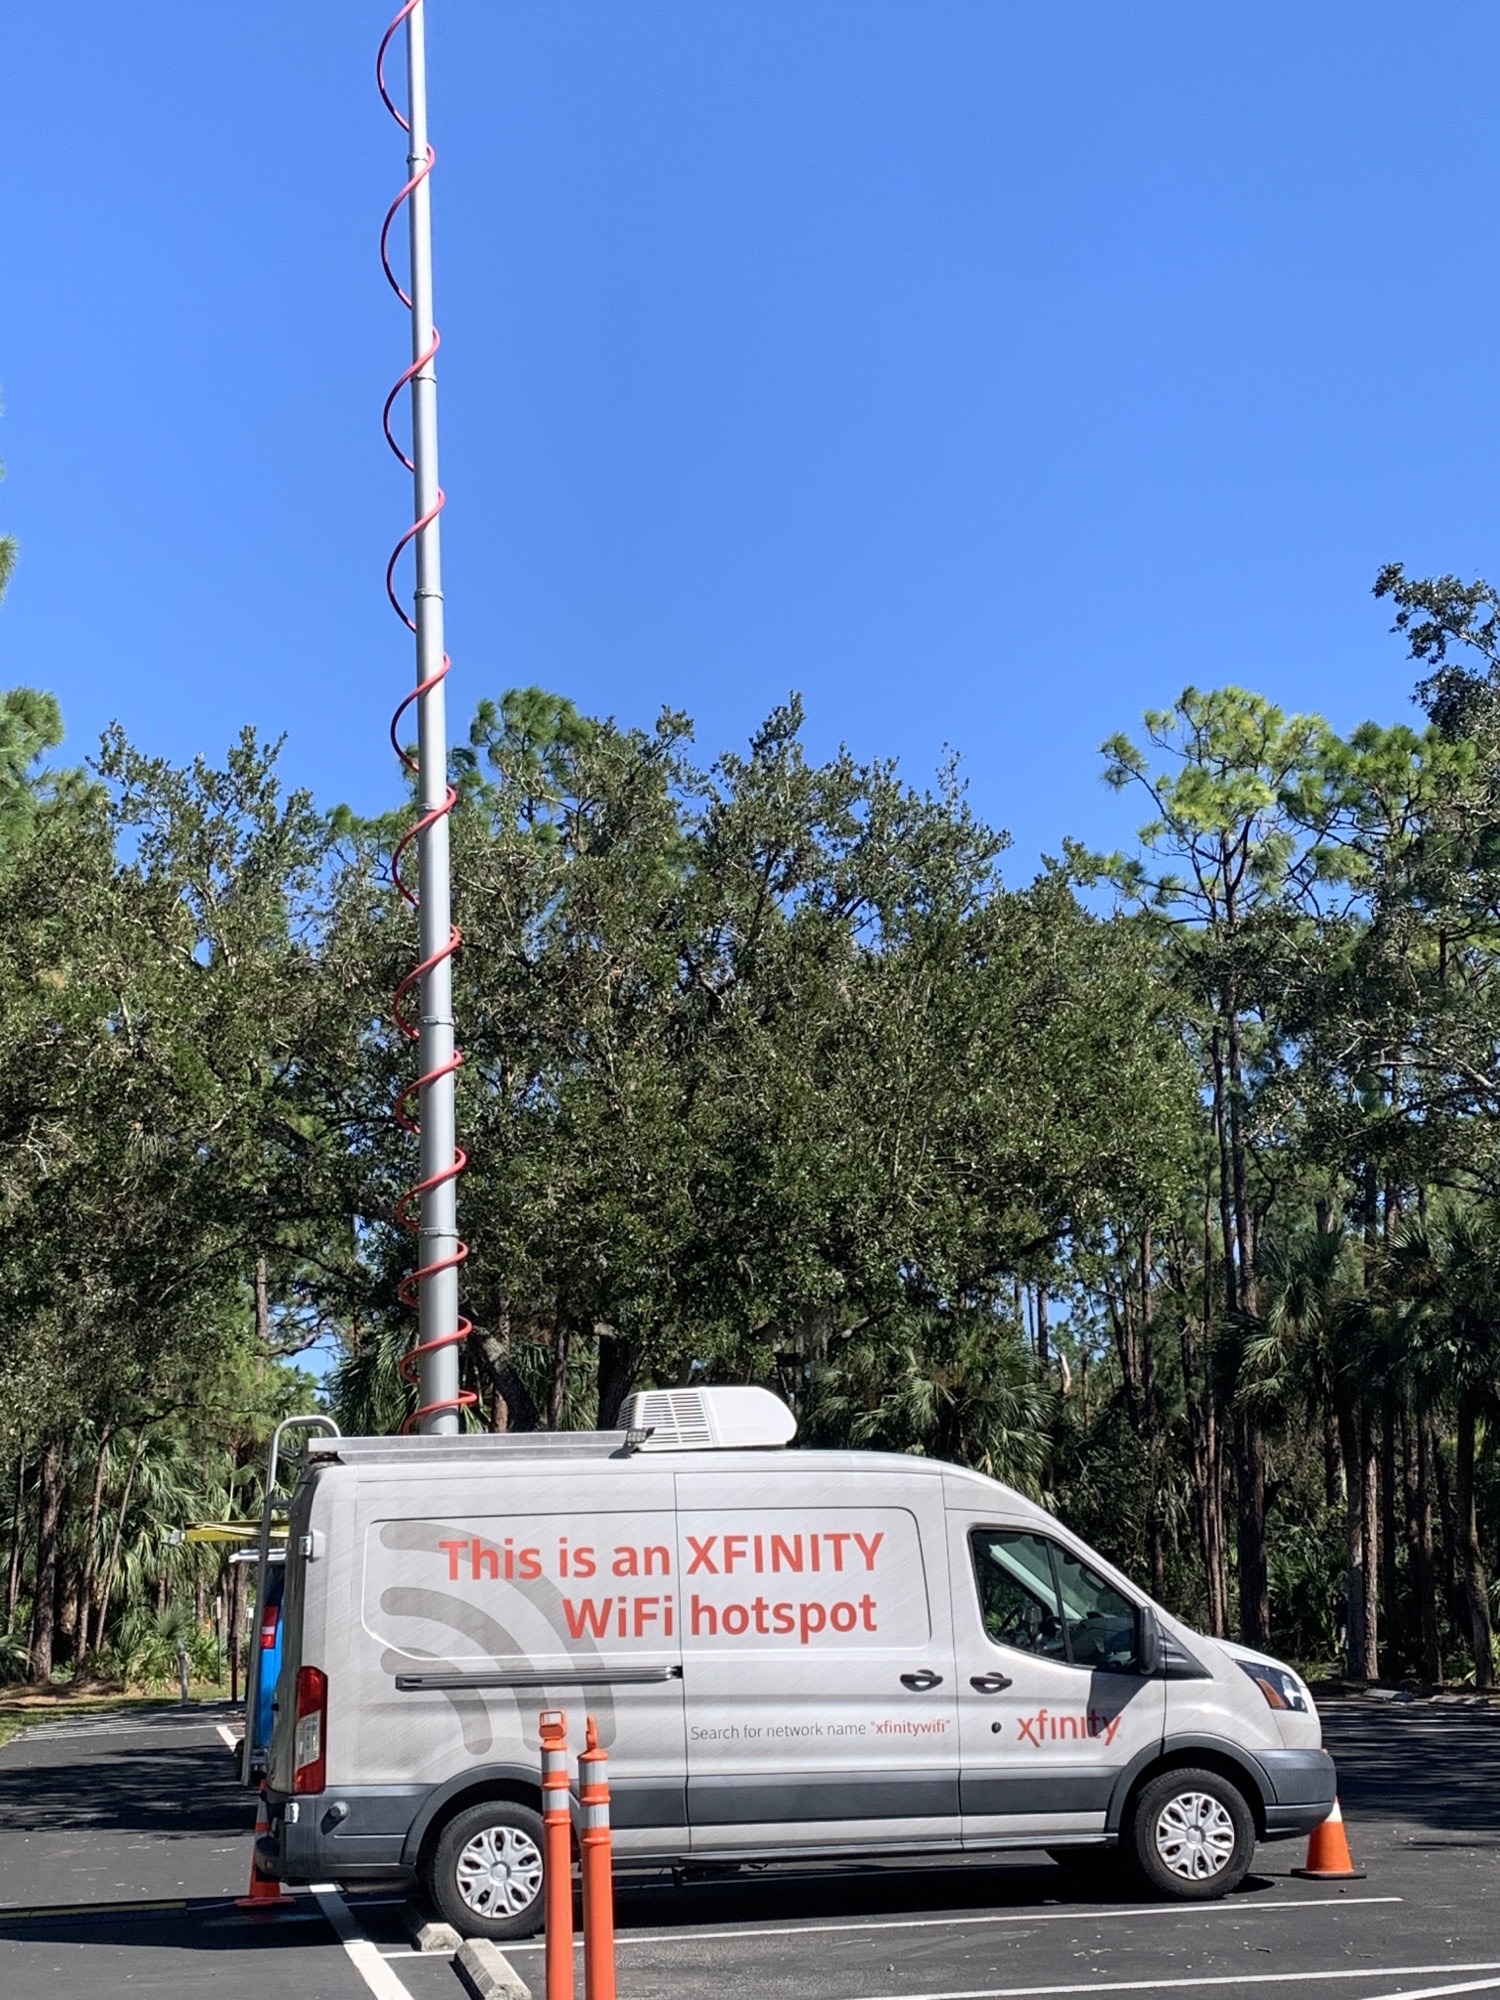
376, 0, 478, 1432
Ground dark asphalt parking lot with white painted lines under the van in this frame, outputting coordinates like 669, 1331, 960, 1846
0, 1700, 1500, 2000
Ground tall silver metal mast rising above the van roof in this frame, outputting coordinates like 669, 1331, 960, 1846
406, 0, 458, 1434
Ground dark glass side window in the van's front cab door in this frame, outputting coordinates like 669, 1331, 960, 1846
968, 1528, 1136, 1672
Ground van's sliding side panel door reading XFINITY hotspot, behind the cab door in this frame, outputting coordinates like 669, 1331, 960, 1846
678, 1466, 960, 1852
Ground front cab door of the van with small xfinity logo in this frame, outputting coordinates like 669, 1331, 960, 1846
948, 1502, 1166, 1846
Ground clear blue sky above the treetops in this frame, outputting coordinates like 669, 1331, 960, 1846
0, 0, 1500, 874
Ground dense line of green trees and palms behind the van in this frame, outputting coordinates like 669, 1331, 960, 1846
0, 568, 1500, 1686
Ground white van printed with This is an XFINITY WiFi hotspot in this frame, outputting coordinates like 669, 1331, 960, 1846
260, 1388, 1334, 1938
